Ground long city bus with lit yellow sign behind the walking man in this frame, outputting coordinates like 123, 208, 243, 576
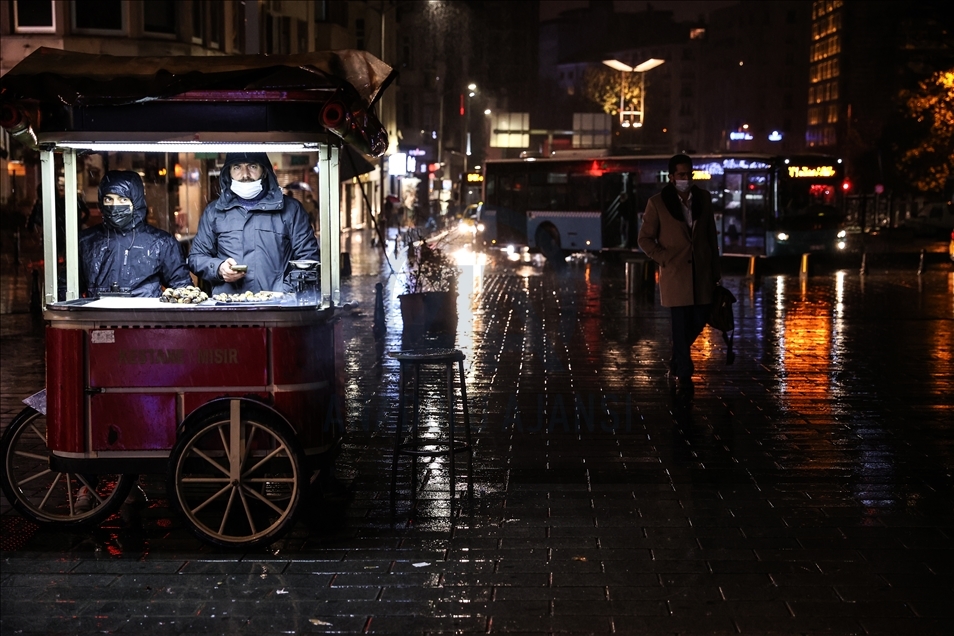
478, 154, 846, 258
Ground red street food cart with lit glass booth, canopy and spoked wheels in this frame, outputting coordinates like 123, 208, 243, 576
0, 49, 393, 548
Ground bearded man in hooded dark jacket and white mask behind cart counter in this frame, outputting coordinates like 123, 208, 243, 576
189, 153, 318, 294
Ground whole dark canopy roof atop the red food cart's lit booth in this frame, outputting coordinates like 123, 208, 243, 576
0, 48, 396, 156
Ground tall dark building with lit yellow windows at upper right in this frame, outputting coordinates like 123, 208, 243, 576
805, 0, 954, 194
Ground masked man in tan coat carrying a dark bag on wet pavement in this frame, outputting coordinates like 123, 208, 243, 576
638, 155, 722, 388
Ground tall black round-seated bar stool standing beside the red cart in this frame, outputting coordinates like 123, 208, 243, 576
391, 349, 474, 512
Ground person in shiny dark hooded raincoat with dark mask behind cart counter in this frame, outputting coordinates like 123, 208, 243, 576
79, 170, 192, 298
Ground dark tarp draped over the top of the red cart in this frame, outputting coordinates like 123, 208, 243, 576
0, 48, 396, 155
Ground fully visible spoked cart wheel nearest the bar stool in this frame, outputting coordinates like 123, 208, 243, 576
168, 400, 307, 549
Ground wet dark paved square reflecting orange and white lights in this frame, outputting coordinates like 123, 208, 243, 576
0, 234, 954, 635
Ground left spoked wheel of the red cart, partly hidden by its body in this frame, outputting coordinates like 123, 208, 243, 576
0, 407, 137, 527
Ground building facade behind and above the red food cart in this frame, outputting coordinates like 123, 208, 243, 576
0, 0, 398, 236
